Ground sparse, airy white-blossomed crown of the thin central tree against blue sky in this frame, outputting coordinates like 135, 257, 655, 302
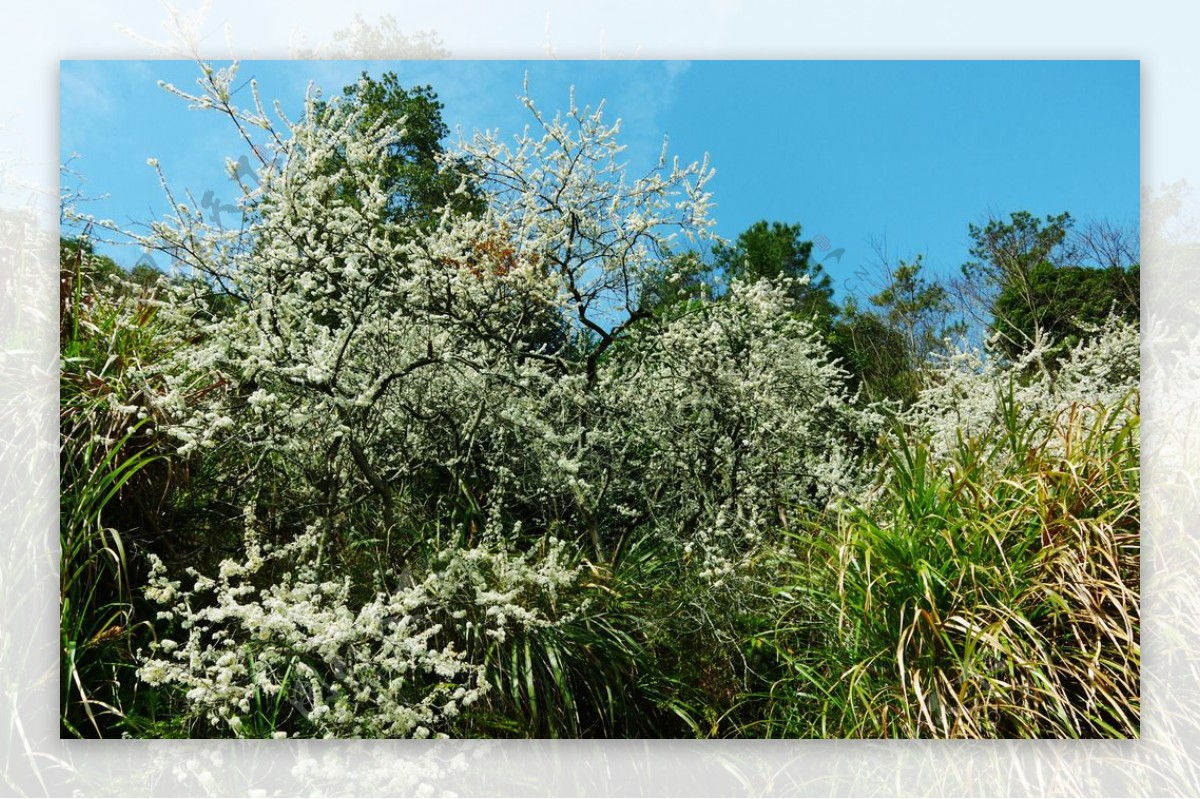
463, 86, 714, 332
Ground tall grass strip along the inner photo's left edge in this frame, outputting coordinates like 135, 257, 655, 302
59, 241, 169, 737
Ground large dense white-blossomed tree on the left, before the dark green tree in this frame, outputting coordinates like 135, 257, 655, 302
148, 68, 547, 566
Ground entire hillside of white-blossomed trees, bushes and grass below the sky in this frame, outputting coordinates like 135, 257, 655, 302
60, 66, 1140, 738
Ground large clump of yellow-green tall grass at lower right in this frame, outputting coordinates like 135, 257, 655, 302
757, 392, 1140, 738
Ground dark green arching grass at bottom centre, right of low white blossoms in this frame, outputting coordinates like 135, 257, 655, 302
453, 534, 719, 738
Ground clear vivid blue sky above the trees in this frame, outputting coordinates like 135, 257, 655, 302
60, 61, 1140, 302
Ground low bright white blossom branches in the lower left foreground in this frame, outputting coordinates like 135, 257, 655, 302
138, 519, 581, 738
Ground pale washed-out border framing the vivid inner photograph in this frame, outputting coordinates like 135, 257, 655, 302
0, 0, 1200, 795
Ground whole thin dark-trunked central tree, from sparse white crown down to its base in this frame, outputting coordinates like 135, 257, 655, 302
451, 85, 729, 560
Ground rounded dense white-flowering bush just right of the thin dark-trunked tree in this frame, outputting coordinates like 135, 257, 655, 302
602, 275, 860, 576
